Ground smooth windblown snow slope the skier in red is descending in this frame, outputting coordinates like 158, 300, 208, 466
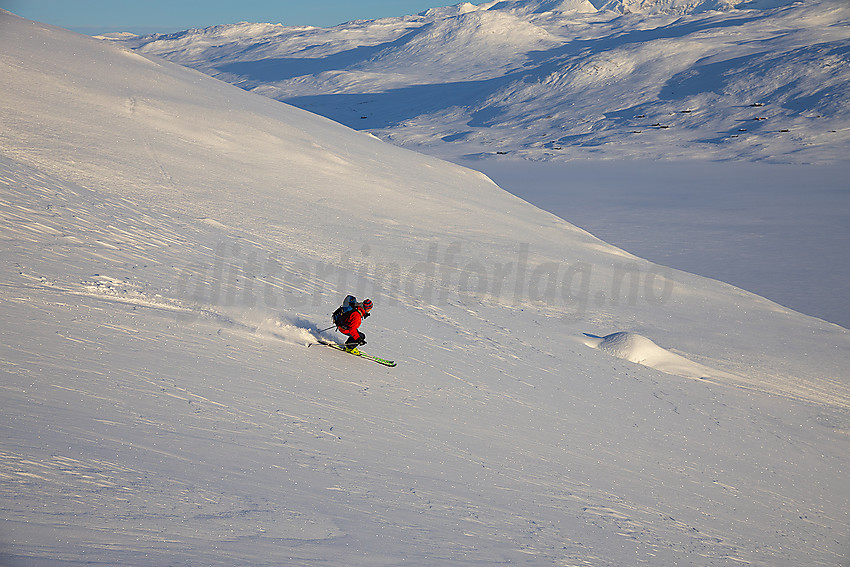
0, 8, 850, 567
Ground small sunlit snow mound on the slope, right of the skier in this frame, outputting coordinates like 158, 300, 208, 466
584, 331, 727, 378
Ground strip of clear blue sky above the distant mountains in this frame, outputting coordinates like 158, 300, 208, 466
0, 0, 470, 34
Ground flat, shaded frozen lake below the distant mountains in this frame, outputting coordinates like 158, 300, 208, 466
458, 160, 850, 328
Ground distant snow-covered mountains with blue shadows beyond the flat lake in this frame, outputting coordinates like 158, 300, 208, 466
114, 0, 850, 163
